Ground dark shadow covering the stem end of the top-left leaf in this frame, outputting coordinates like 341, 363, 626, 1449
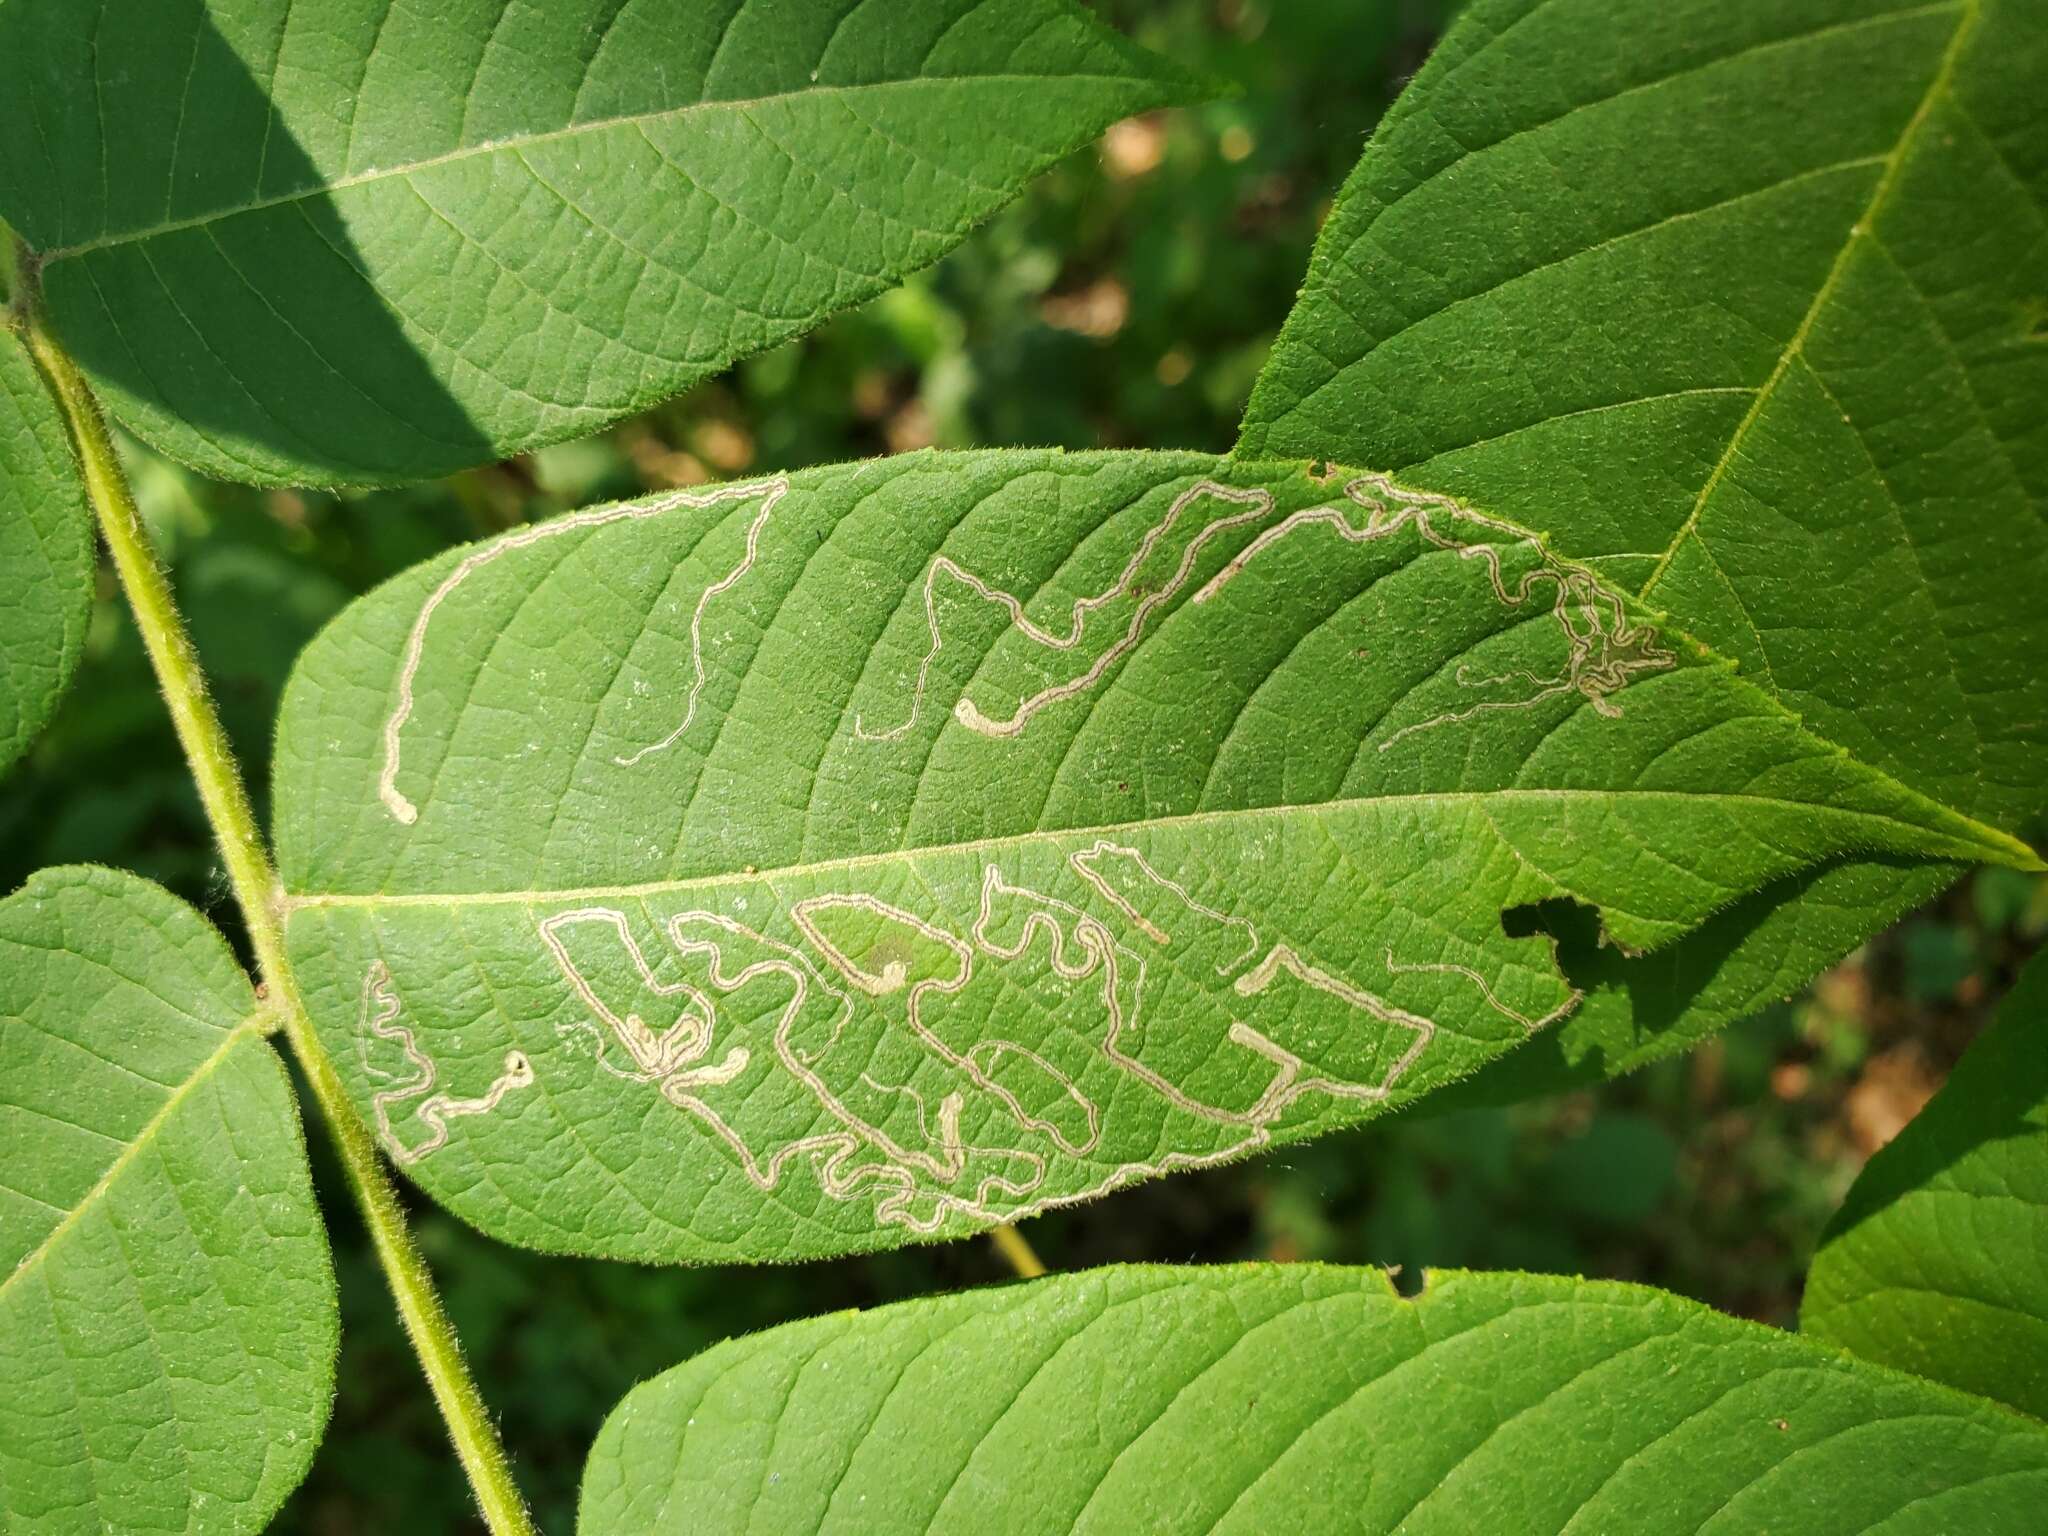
0, 0, 496, 483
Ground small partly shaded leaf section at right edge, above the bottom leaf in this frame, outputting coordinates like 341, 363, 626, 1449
1800, 956, 2048, 1419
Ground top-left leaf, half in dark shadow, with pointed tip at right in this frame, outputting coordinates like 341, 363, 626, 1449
0, 0, 1200, 483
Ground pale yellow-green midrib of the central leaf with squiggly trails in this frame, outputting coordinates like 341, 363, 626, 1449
279, 780, 2042, 915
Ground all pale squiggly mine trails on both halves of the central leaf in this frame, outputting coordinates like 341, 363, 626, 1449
344, 462, 1675, 1233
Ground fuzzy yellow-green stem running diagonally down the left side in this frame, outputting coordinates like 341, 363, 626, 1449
27, 315, 535, 1536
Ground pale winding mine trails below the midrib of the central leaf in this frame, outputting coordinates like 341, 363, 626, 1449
360, 840, 1577, 1233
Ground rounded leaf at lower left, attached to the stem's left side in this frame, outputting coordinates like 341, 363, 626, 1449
0, 866, 336, 1534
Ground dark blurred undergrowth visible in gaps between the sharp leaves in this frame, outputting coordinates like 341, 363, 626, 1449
0, 0, 2048, 1536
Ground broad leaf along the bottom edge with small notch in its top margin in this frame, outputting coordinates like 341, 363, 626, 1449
578, 1266, 2048, 1536
